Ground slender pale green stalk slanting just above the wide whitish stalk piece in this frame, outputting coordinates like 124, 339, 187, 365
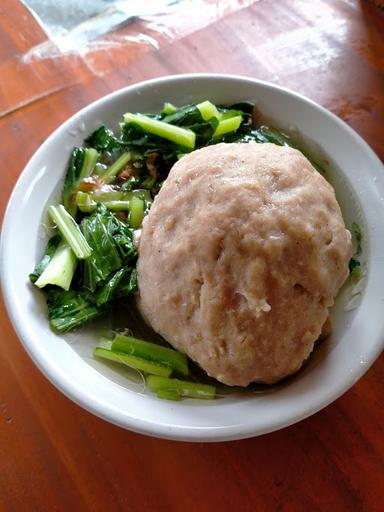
48, 204, 92, 260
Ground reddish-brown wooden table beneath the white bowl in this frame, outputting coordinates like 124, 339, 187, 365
0, 0, 384, 512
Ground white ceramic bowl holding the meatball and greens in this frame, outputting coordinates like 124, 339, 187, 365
1, 74, 384, 441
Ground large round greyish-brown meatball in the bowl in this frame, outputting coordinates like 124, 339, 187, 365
138, 143, 351, 386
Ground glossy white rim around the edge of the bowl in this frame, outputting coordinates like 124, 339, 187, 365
0, 73, 384, 442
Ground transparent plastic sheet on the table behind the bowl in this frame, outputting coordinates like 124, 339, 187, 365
0, 0, 255, 117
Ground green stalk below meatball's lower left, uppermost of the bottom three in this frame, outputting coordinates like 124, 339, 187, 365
112, 334, 188, 375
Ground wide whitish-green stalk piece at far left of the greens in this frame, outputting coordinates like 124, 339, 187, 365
35, 240, 77, 290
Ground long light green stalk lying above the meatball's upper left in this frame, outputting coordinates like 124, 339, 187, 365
124, 114, 196, 149
